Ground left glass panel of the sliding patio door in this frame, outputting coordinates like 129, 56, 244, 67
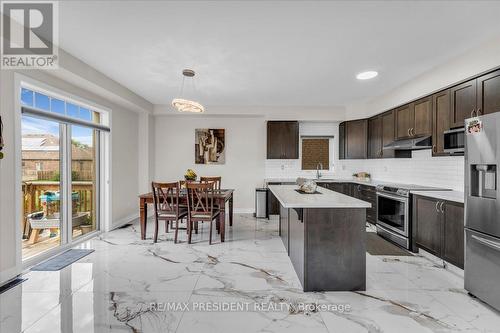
21, 115, 64, 259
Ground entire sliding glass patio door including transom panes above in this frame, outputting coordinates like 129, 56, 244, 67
20, 88, 109, 260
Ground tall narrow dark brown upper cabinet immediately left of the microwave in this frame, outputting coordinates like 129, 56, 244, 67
432, 89, 450, 156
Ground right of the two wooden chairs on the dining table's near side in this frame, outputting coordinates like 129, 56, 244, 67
186, 182, 220, 245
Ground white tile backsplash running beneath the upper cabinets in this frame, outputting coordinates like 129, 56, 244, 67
265, 149, 464, 191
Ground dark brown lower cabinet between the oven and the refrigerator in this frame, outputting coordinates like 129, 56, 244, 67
413, 195, 464, 268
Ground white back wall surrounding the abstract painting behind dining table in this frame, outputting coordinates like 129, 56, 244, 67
155, 115, 266, 212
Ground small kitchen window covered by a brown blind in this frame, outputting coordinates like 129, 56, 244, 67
302, 138, 330, 170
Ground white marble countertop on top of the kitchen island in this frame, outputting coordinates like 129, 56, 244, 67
269, 185, 371, 208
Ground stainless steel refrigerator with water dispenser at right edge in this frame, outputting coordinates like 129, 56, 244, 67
464, 112, 500, 310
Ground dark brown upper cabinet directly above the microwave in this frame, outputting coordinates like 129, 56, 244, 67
450, 79, 477, 128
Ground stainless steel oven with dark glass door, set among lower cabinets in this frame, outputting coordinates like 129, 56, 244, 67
377, 189, 410, 249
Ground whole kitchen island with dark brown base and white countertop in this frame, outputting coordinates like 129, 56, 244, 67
269, 185, 371, 291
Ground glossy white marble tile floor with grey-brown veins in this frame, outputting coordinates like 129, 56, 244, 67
0, 215, 500, 333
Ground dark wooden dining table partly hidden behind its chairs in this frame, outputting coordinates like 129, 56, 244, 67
139, 189, 234, 242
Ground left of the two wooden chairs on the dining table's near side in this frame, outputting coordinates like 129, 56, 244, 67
152, 182, 188, 243
